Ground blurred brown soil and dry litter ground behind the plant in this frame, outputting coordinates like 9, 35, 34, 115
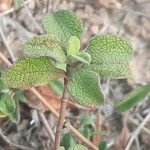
0, 0, 150, 150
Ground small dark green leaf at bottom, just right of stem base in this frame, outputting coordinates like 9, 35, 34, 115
62, 133, 75, 149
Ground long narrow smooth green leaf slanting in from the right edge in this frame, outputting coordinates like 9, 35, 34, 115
115, 85, 150, 112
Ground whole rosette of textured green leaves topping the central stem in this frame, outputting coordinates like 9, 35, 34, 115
2, 10, 133, 112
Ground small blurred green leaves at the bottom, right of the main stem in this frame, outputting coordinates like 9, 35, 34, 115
61, 115, 106, 150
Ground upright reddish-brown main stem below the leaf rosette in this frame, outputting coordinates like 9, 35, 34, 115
54, 78, 69, 150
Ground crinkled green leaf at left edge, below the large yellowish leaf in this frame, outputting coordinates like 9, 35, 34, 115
0, 94, 16, 120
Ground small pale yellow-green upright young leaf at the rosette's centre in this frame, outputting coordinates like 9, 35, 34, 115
67, 36, 80, 56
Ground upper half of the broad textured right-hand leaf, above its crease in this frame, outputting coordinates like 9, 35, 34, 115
87, 35, 133, 64
